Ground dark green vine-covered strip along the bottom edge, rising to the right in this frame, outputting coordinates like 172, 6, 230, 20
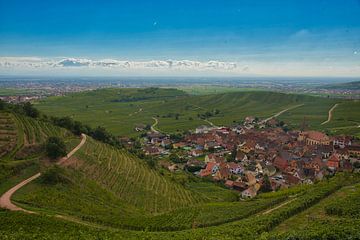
0, 174, 360, 239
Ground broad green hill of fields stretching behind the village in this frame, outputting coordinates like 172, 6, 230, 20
37, 88, 360, 136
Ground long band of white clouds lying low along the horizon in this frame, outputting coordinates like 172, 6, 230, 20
0, 57, 360, 77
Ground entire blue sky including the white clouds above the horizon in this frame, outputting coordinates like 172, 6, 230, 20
0, 0, 360, 77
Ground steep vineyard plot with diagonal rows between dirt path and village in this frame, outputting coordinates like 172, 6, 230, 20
68, 138, 205, 213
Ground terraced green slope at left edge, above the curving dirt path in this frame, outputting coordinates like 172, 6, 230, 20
0, 112, 79, 193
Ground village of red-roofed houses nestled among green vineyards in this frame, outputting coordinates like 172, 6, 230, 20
124, 117, 360, 198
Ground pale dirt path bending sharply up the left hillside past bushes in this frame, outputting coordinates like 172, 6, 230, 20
0, 134, 86, 213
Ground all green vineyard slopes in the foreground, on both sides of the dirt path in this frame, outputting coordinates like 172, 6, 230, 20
0, 107, 360, 239
